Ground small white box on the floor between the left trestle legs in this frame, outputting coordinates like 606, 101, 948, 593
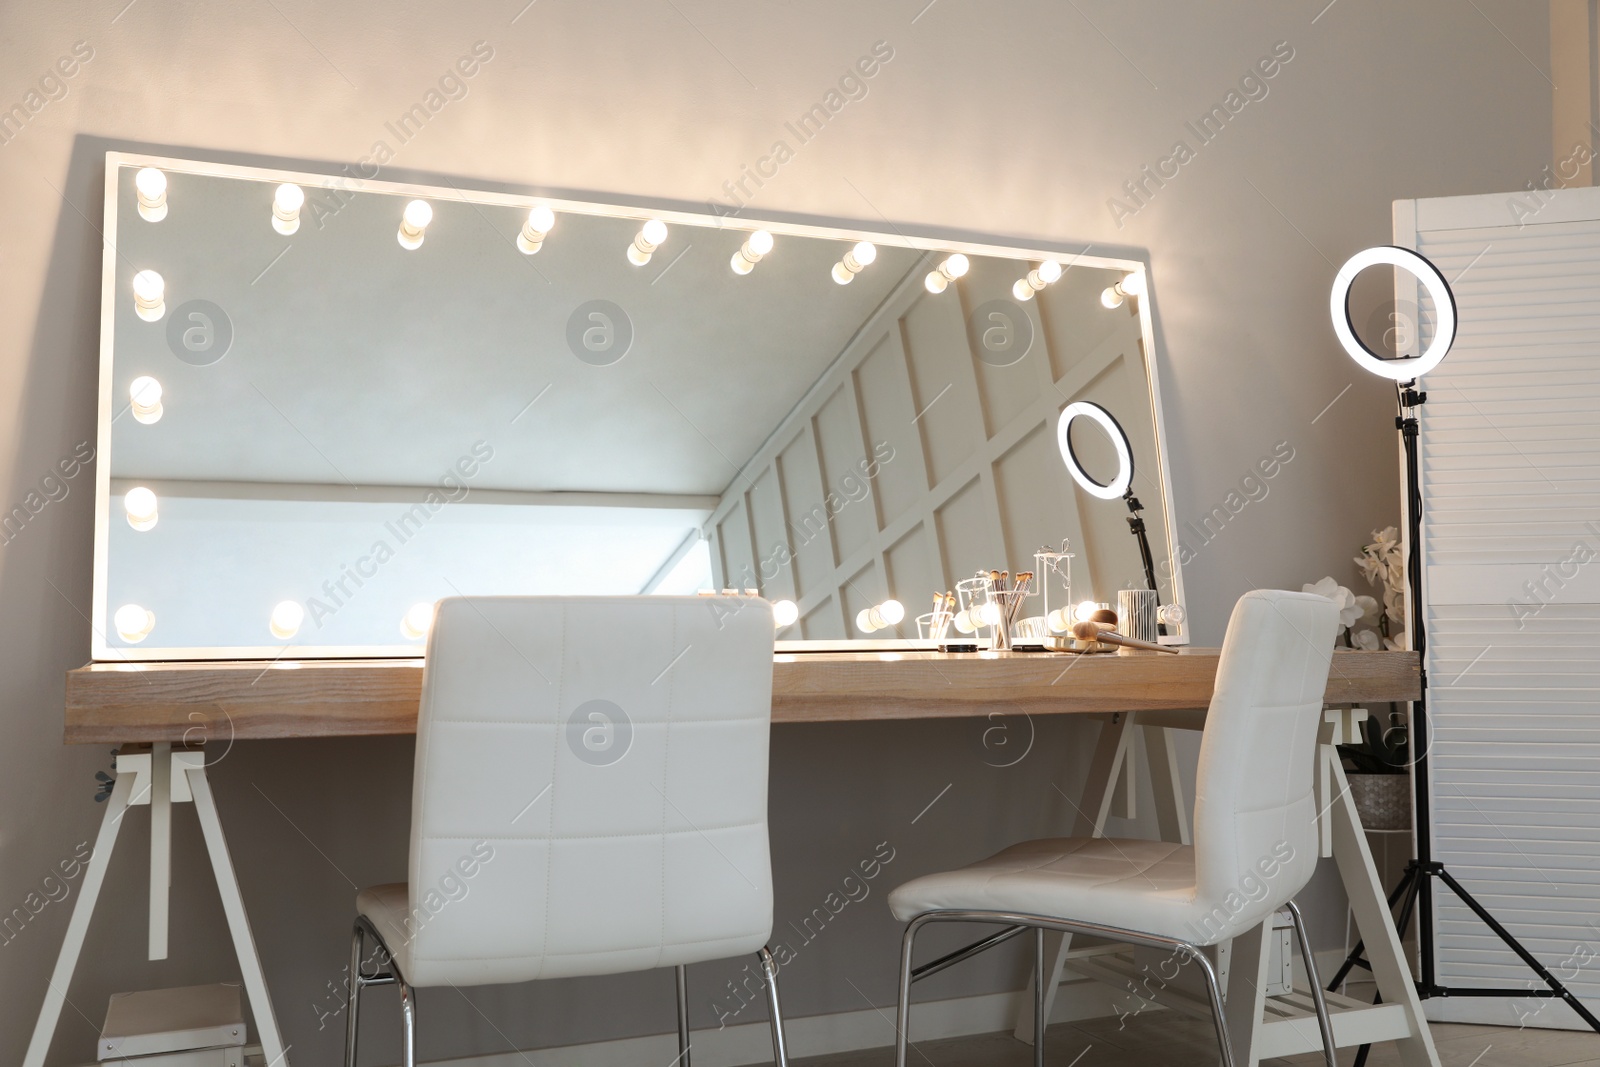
96, 982, 245, 1067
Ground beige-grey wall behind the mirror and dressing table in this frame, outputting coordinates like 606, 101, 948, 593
0, 0, 1552, 1062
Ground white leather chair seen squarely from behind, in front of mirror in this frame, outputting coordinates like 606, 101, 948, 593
346, 597, 787, 1067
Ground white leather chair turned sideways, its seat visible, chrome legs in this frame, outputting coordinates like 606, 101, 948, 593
888, 590, 1339, 1067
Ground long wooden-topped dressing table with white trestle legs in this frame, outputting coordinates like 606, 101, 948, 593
34, 648, 1438, 1067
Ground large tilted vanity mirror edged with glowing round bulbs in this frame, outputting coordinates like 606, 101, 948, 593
93, 146, 1186, 659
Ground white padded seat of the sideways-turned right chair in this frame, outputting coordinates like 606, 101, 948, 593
890, 837, 1261, 945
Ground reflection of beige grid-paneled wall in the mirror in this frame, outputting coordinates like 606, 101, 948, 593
709, 254, 1174, 638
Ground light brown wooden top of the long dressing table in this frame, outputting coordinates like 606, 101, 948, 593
66, 648, 1421, 744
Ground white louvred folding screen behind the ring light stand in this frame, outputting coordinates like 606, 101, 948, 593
1395, 189, 1600, 1027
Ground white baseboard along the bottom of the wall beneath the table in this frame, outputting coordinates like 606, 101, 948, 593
412, 979, 1131, 1067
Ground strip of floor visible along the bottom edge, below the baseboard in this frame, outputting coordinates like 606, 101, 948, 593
798, 1013, 1600, 1067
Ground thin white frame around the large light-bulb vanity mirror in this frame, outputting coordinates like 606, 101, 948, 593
90, 150, 1189, 662
